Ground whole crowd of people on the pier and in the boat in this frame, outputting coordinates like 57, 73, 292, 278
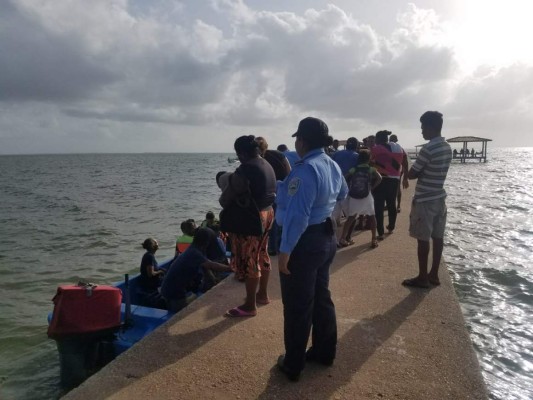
141, 111, 452, 381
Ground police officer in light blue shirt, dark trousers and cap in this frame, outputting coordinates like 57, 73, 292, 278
276, 117, 348, 381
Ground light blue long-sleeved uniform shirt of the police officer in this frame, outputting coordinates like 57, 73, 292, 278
276, 149, 348, 253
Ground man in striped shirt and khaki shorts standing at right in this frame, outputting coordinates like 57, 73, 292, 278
402, 111, 452, 288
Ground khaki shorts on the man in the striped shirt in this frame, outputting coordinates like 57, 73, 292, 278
409, 197, 447, 242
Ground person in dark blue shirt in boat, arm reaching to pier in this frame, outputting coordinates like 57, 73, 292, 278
161, 228, 231, 312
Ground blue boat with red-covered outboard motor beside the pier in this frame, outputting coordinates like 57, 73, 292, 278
48, 259, 176, 390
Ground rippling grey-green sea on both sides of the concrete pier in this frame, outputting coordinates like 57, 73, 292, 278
0, 148, 533, 400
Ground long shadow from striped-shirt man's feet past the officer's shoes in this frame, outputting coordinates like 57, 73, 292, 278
258, 291, 428, 400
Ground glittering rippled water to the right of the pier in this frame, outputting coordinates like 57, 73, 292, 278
445, 148, 533, 400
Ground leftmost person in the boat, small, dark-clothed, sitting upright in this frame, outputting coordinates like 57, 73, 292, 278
139, 238, 165, 308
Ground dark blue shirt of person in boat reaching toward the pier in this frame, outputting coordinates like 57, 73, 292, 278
161, 245, 208, 300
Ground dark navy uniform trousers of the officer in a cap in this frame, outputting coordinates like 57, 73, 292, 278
280, 219, 337, 372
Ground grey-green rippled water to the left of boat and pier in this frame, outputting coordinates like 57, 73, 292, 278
0, 154, 229, 399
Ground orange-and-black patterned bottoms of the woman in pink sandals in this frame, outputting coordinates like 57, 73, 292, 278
230, 208, 274, 279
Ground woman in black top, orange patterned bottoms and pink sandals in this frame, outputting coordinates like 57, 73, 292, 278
220, 135, 276, 317
